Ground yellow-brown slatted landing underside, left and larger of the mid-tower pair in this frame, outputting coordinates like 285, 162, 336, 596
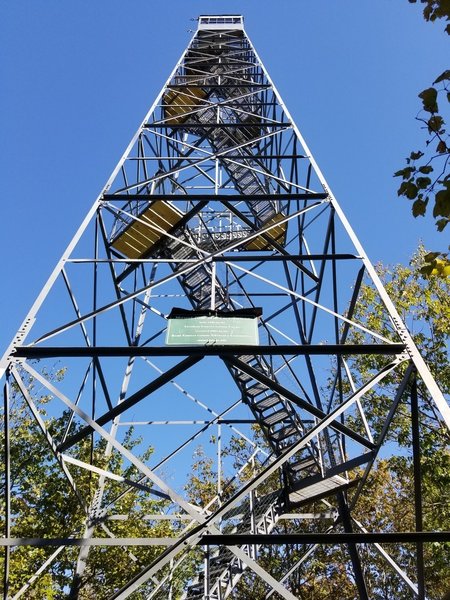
112, 200, 184, 258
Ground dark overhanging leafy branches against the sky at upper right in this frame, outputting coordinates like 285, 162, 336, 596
394, 0, 450, 276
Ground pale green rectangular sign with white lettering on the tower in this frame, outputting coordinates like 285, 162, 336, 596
166, 317, 259, 346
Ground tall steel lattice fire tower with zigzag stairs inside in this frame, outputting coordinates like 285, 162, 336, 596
1, 15, 450, 600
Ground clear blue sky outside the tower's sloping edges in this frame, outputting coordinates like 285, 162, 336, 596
0, 0, 448, 353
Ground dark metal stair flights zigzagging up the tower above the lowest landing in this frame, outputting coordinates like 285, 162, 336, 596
153, 34, 320, 496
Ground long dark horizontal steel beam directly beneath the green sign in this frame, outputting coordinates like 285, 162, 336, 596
14, 344, 405, 359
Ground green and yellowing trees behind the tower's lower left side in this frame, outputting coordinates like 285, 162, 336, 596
0, 371, 179, 600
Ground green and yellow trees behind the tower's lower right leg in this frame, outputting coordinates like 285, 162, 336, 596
349, 248, 450, 600
